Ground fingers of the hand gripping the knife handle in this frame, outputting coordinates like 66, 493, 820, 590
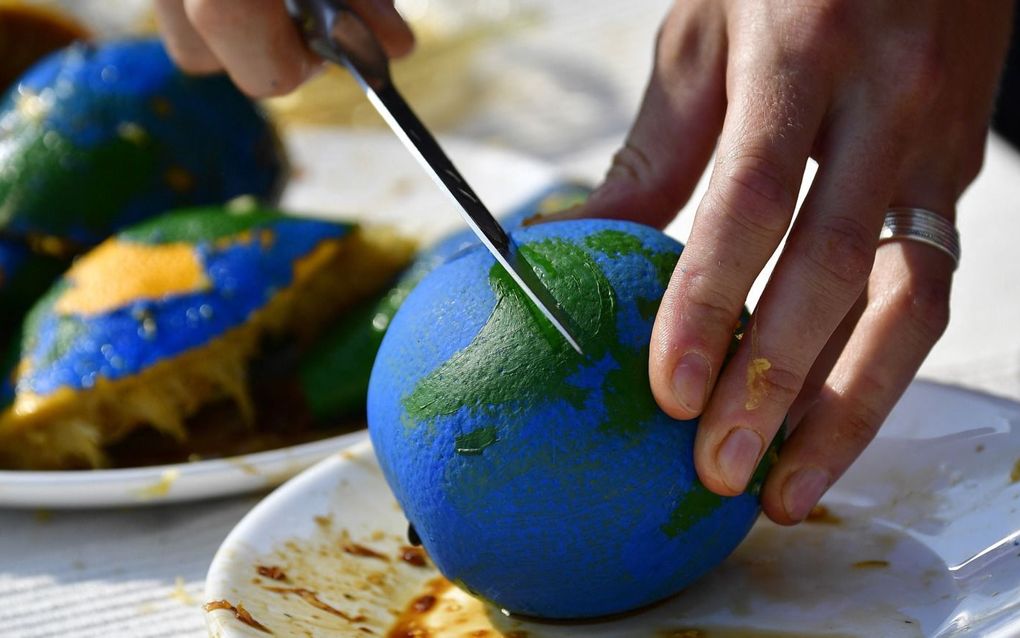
155, 0, 414, 97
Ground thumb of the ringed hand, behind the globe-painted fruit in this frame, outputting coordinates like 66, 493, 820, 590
551, 0, 726, 228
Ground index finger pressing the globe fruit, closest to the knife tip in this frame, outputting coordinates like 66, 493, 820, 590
649, 38, 825, 432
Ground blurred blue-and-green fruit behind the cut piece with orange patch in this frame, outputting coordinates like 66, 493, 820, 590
0, 40, 286, 246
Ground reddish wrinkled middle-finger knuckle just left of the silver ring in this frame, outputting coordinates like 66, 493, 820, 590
805, 216, 878, 288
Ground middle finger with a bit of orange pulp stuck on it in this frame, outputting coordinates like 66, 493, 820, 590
695, 109, 896, 494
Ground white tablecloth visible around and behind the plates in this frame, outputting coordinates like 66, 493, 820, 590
0, 0, 1020, 637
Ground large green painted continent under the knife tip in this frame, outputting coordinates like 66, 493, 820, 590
403, 231, 676, 443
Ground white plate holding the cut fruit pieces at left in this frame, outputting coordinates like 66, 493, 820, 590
0, 128, 556, 507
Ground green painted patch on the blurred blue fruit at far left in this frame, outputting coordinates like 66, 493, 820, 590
0, 117, 160, 237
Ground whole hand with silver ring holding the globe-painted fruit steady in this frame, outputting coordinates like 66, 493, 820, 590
561, 0, 1013, 524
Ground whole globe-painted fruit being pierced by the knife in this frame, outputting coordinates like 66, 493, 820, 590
368, 220, 774, 619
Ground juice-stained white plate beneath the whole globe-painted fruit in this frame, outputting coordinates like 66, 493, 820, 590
205, 382, 1020, 638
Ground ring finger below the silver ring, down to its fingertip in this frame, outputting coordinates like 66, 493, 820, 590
762, 233, 953, 524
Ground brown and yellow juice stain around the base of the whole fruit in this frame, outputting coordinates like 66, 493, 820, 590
207, 506, 954, 638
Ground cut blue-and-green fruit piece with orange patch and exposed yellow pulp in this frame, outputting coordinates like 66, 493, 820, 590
0, 207, 411, 469
